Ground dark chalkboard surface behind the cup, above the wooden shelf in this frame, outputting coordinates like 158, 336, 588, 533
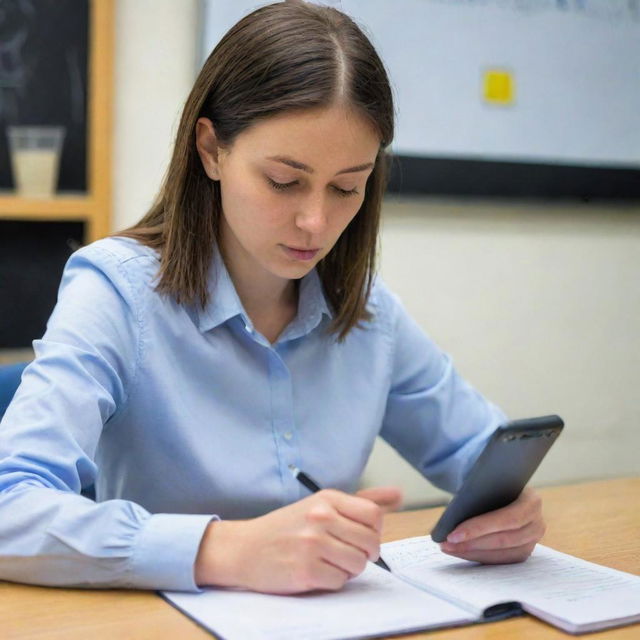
0, 0, 89, 191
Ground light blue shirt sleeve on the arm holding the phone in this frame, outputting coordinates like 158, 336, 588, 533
380, 294, 505, 492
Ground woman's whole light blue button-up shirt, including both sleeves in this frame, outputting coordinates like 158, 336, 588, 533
0, 238, 504, 590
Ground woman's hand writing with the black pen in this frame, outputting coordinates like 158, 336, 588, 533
195, 487, 401, 594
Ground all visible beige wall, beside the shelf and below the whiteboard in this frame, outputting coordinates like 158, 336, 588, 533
114, 0, 640, 503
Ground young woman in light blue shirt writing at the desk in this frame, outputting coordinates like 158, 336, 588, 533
0, 1, 543, 593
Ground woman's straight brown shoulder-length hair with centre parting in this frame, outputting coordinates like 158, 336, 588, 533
117, 0, 393, 339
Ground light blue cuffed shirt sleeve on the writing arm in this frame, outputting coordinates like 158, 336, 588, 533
0, 247, 211, 590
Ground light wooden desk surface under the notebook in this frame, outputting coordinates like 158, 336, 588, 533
0, 478, 640, 640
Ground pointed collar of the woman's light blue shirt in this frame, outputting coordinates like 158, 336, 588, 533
198, 248, 333, 342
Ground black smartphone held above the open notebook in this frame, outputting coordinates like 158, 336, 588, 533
431, 415, 564, 542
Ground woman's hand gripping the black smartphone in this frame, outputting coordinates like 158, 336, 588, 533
440, 488, 545, 564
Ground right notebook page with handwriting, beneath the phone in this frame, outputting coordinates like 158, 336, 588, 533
383, 536, 640, 630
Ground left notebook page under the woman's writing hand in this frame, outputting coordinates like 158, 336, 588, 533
162, 563, 473, 640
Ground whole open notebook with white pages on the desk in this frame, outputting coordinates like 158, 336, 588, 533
161, 536, 640, 640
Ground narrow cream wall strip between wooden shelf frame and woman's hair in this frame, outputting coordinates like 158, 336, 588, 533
113, 0, 199, 230
